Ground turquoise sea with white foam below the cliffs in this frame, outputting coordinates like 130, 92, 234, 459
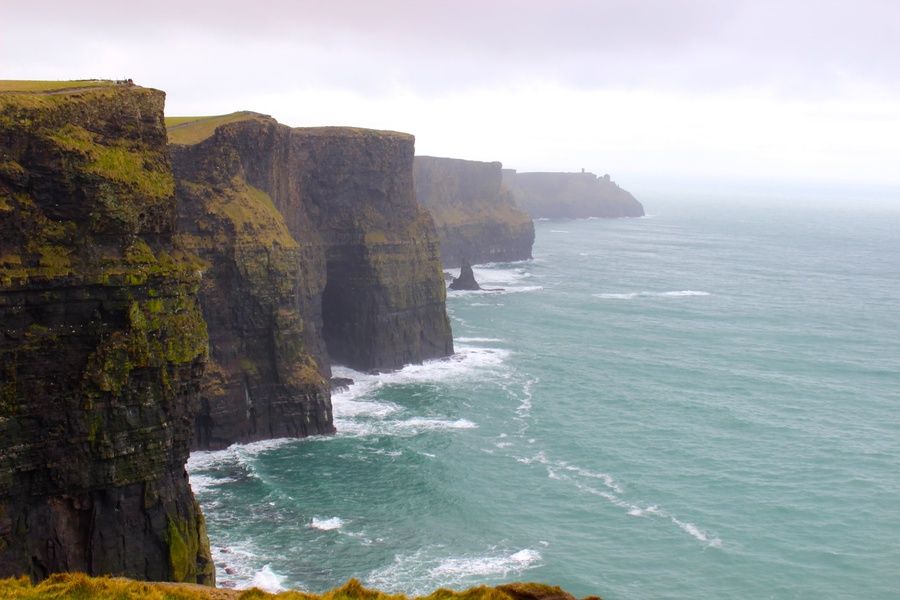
189, 195, 900, 600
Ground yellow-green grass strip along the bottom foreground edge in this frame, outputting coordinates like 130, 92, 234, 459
0, 573, 600, 600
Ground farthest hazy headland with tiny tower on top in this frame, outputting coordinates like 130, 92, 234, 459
503, 169, 644, 219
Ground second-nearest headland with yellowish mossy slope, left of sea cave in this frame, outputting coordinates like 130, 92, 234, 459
170, 114, 334, 449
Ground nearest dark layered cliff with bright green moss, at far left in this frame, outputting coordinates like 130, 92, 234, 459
0, 82, 214, 584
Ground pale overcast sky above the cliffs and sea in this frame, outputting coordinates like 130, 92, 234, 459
0, 0, 900, 188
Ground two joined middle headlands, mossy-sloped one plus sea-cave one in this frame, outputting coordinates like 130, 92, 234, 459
169, 113, 453, 447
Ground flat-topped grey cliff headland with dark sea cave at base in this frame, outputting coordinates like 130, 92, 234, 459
292, 127, 453, 370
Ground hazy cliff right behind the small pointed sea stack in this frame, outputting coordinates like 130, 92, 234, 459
415, 156, 534, 267
